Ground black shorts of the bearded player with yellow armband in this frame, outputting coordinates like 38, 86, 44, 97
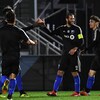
58, 52, 80, 72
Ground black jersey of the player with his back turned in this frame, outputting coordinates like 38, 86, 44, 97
0, 24, 29, 58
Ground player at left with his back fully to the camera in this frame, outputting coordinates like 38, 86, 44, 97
0, 11, 35, 100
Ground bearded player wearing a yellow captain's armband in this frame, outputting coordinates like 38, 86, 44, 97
44, 13, 83, 96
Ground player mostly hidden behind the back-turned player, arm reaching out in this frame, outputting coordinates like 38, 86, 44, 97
0, 6, 43, 97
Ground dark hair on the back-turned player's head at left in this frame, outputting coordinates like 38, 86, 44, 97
5, 11, 16, 23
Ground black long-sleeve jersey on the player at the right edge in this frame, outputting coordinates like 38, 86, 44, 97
86, 29, 100, 54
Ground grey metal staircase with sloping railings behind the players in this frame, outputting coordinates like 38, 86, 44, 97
17, 19, 63, 55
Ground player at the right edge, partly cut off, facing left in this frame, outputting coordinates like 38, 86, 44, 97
80, 15, 100, 96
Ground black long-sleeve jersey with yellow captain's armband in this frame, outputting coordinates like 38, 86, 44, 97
44, 25, 84, 52
